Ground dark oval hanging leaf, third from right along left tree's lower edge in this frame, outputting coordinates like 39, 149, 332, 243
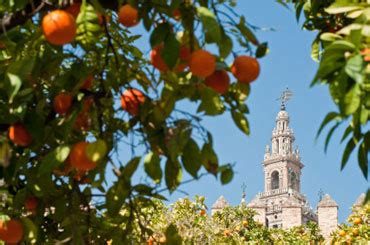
181, 139, 202, 178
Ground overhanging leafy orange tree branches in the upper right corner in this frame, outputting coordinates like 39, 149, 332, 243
278, 0, 370, 199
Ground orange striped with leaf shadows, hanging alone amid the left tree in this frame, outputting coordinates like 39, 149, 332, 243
121, 89, 145, 116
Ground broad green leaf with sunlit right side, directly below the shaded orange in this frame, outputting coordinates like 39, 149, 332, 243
197, 88, 225, 116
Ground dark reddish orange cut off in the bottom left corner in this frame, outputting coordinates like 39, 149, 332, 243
0, 219, 24, 243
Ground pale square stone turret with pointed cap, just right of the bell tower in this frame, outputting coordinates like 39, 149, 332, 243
317, 194, 338, 239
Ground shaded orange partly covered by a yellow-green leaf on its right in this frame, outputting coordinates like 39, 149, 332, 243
68, 141, 96, 171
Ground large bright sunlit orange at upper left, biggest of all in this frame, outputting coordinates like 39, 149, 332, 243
42, 10, 77, 45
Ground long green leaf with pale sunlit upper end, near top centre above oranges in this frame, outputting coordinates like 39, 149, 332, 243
197, 7, 222, 45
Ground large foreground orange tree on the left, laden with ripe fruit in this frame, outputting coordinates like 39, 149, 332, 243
0, 0, 267, 244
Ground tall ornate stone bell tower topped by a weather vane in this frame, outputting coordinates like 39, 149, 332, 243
248, 94, 317, 228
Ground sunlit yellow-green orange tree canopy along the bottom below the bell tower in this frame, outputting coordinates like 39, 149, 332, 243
115, 196, 324, 244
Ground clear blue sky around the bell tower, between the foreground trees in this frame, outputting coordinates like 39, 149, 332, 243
112, 0, 369, 222
